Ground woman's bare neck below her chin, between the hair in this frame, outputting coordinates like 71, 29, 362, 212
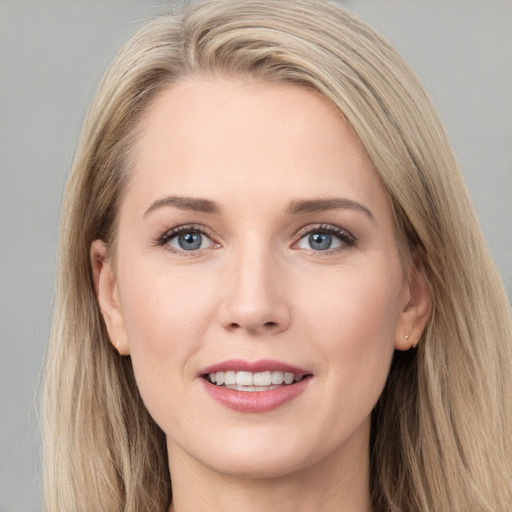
168, 428, 371, 512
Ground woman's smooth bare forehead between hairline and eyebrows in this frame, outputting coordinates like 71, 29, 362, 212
128, 78, 384, 216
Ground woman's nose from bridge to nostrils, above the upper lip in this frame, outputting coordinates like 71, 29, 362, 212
218, 244, 291, 335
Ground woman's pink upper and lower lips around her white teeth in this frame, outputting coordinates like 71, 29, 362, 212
199, 360, 312, 413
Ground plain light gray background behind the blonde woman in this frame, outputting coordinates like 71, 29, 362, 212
0, 0, 512, 512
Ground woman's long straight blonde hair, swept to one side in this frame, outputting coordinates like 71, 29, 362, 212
43, 0, 512, 512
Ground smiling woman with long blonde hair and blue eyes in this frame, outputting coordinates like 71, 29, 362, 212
45, 0, 512, 512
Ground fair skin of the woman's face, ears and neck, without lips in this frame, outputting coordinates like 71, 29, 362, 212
91, 78, 430, 512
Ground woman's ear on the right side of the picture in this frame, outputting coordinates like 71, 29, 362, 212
395, 256, 432, 350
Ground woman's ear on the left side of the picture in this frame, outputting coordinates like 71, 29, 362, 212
90, 240, 130, 356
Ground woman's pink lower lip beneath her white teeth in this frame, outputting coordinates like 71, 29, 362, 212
201, 377, 311, 413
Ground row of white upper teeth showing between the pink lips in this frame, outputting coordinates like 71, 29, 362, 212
208, 371, 303, 391
